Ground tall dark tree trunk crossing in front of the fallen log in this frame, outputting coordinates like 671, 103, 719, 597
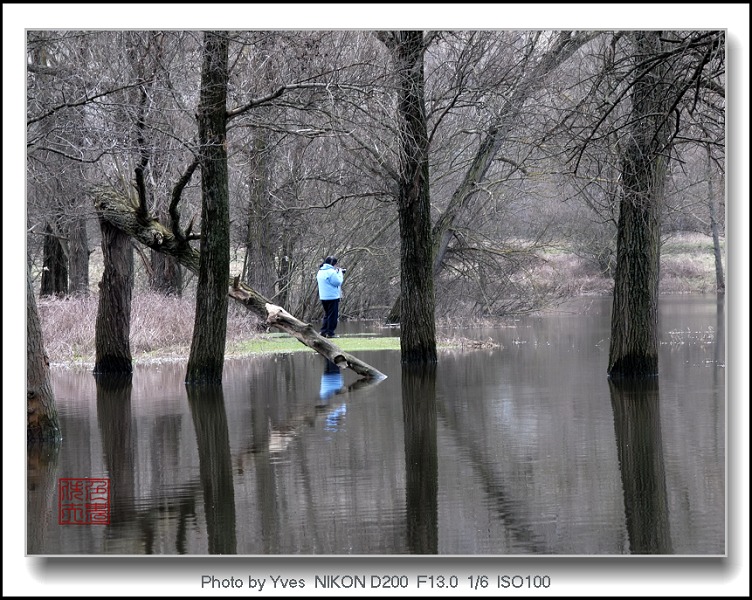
185, 32, 230, 383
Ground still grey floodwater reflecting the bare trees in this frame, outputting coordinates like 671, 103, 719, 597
27, 296, 726, 555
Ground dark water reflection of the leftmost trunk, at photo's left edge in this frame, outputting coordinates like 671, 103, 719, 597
26, 440, 60, 554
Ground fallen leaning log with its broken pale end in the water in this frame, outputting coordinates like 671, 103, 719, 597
94, 188, 386, 379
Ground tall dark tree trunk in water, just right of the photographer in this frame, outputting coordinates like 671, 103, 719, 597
385, 31, 437, 363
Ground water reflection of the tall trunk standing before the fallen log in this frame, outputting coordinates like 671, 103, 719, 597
186, 385, 237, 554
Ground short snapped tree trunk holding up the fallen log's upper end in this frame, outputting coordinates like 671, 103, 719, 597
94, 219, 133, 374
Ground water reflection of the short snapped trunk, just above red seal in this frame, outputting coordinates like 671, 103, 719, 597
94, 373, 135, 537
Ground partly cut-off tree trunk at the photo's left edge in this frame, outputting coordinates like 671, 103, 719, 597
26, 274, 61, 444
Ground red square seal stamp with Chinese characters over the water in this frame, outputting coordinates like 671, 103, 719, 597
57, 478, 110, 525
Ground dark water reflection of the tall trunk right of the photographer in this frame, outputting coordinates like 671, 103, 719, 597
402, 365, 439, 554
